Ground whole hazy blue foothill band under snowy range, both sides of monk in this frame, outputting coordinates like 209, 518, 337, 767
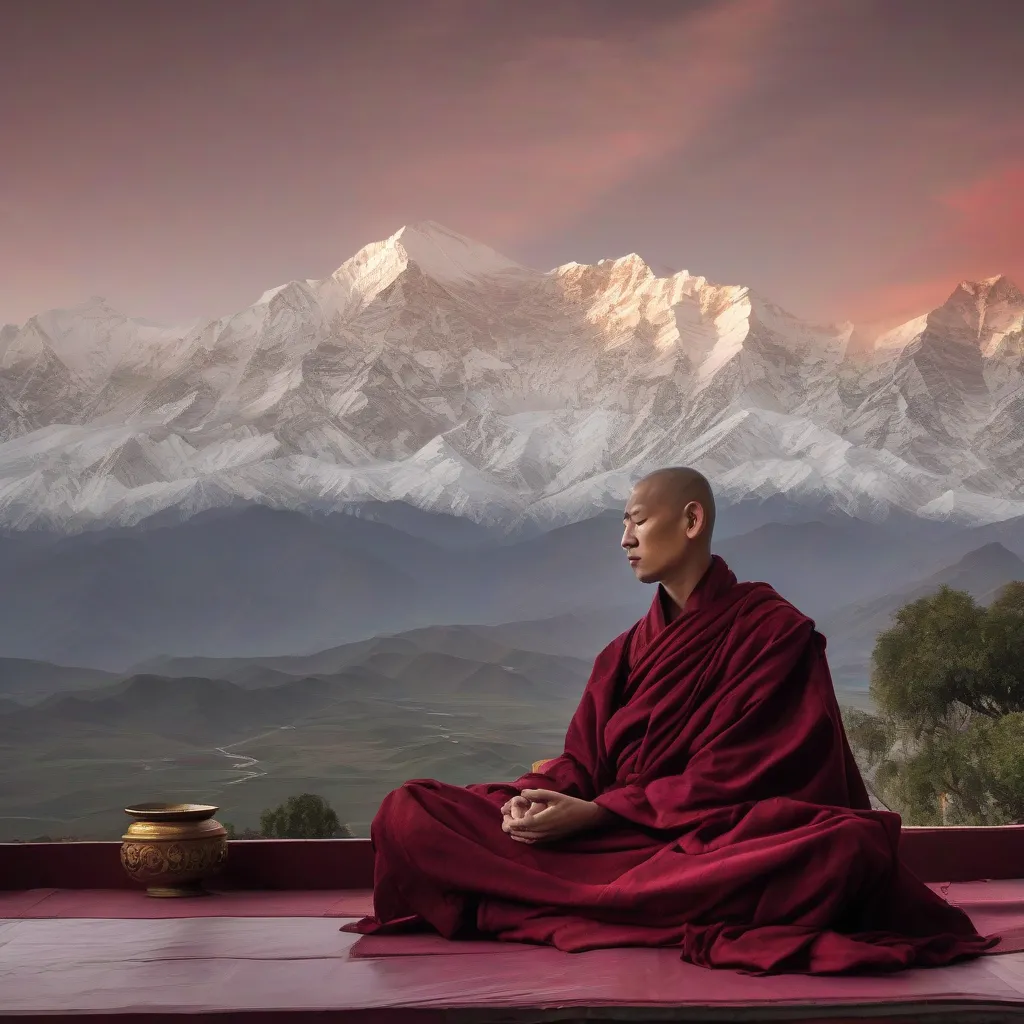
0, 503, 1024, 675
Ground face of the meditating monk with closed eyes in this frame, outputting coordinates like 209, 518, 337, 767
622, 481, 705, 583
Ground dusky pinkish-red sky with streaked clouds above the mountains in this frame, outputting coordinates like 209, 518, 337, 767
0, 0, 1024, 323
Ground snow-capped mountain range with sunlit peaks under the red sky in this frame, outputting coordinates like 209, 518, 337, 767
0, 223, 1024, 531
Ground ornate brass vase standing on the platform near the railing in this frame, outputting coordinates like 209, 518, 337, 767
121, 804, 227, 896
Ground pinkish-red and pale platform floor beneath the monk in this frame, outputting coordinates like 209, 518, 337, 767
0, 880, 1024, 1024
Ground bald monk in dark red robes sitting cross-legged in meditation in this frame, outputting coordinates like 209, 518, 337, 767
346, 469, 997, 974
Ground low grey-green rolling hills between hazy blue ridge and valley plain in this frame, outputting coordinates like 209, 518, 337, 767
8, 630, 591, 742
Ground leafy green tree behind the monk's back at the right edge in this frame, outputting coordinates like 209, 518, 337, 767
845, 582, 1024, 824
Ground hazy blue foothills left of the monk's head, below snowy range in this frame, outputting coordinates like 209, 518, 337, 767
0, 506, 649, 673
